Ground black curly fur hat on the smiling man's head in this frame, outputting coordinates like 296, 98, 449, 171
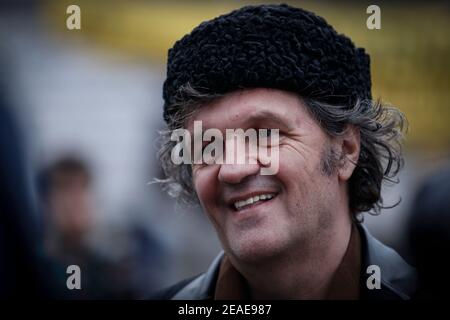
163, 4, 372, 121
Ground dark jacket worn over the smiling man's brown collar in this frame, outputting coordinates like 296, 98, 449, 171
152, 225, 417, 300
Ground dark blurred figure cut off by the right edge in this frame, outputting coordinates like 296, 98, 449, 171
408, 167, 450, 299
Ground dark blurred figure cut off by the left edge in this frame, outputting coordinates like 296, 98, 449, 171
0, 64, 65, 298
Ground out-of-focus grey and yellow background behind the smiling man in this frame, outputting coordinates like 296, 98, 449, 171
0, 0, 450, 298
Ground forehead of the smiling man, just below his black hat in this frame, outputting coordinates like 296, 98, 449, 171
187, 88, 308, 130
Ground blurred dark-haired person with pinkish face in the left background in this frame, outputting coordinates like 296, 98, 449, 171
40, 156, 133, 299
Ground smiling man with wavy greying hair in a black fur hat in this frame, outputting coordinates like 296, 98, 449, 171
159, 5, 415, 299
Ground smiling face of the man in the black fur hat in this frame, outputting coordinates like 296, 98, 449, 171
187, 89, 339, 261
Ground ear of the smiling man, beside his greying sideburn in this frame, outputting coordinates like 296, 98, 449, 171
338, 125, 361, 181
